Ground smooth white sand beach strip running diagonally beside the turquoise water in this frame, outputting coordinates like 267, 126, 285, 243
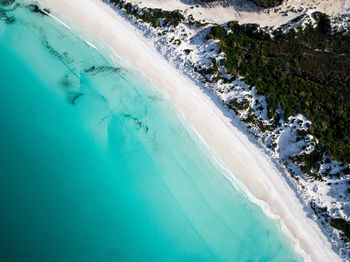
39, 0, 340, 261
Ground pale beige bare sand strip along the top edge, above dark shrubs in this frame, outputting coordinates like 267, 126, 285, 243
129, 0, 350, 26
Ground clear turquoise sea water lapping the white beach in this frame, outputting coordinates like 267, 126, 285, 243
0, 4, 301, 261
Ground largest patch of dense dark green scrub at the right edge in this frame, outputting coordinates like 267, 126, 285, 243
207, 13, 350, 174
